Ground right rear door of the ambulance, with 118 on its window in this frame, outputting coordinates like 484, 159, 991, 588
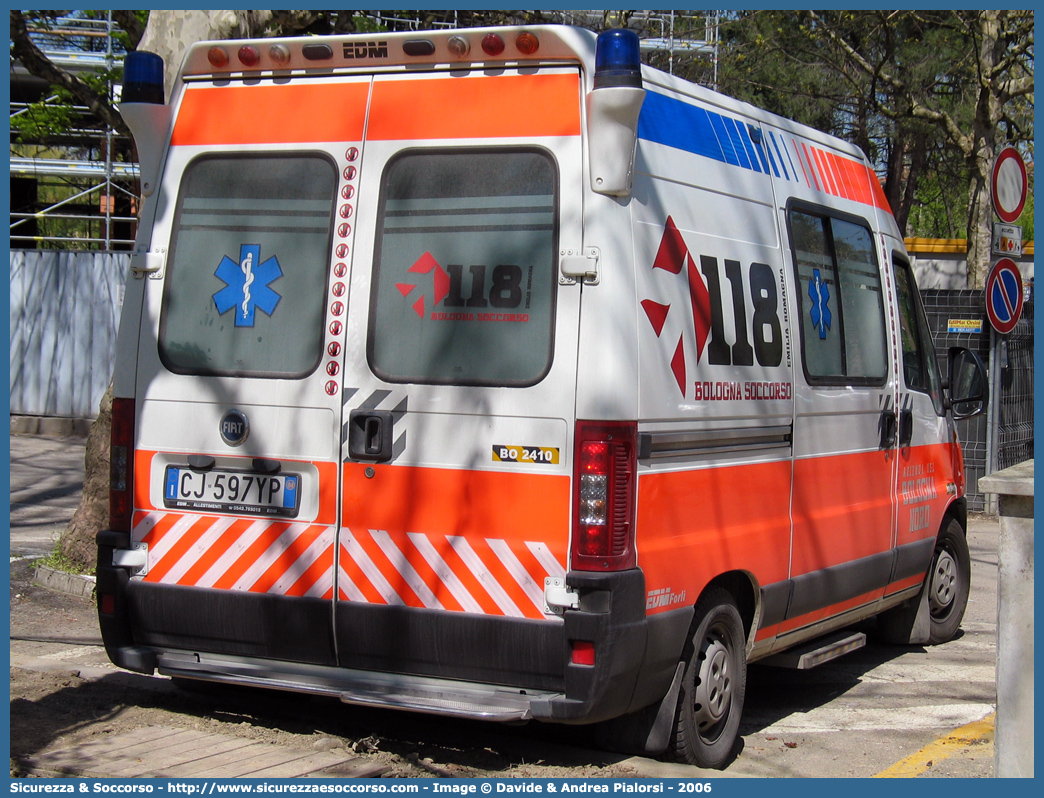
329, 68, 583, 680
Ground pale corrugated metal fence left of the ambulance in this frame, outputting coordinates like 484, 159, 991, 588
10, 250, 131, 419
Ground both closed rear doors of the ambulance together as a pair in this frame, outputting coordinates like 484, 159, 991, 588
134, 68, 583, 676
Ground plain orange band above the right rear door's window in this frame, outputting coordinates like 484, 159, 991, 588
366, 72, 580, 141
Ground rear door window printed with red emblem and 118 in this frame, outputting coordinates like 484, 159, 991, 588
367, 148, 557, 386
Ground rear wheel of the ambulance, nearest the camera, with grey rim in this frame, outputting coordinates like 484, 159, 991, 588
667, 587, 746, 770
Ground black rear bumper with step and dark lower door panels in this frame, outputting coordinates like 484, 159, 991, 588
97, 532, 691, 723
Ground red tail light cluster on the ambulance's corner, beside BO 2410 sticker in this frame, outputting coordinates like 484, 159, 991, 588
570, 421, 638, 570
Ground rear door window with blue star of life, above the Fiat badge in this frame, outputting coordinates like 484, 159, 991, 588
160, 154, 337, 378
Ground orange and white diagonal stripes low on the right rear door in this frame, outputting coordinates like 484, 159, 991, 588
337, 530, 566, 618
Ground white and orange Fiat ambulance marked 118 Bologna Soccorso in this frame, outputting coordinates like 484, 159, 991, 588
97, 26, 987, 768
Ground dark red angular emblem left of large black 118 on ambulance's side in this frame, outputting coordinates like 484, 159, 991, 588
641, 216, 711, 396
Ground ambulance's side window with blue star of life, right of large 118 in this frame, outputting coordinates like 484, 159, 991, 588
788, 209, 888, 384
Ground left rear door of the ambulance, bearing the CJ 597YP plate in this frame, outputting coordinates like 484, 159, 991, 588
132, 77, 370, 664
